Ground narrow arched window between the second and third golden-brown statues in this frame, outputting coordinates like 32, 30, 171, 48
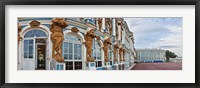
92, 39, 102, 67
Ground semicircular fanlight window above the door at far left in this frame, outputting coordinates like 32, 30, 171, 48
24, 29, 47, 38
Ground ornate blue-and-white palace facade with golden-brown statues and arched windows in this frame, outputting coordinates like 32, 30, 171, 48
18, 18, 136, 70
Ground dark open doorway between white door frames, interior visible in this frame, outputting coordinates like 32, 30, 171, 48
37, 45, 46, 70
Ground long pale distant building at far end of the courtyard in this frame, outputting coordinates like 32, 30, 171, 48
136, 49, 166, 62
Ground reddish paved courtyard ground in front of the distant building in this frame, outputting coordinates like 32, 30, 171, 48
131, 62, 182, 70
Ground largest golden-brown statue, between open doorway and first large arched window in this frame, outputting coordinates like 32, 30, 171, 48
50, 18, 68, 62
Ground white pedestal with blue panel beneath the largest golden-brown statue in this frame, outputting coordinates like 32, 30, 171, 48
51, 58, 65, 70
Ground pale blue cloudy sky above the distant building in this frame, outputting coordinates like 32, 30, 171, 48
124, 17, 183, 56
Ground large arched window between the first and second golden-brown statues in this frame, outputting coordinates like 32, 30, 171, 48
62, 34, 82, 70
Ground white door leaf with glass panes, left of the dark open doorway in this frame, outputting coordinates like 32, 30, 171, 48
22, 39, 35, 70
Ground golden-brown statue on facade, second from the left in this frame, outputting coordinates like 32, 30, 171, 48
84, 29, 100, 62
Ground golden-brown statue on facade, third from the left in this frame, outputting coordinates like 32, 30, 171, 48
103, 38, 112, 62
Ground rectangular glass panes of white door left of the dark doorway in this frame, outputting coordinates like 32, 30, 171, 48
24, 40, 33, 58
